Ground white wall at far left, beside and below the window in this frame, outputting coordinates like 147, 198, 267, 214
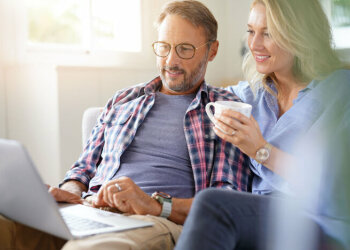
0, 0, 60, 184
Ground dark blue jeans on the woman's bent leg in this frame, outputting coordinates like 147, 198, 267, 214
175, 188, 335, 250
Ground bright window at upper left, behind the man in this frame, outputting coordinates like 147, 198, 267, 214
27, 0, 142, 53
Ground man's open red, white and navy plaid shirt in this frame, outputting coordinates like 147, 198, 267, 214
63, 77, 251, 194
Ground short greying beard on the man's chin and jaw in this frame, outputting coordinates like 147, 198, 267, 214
160, 56, 208, 92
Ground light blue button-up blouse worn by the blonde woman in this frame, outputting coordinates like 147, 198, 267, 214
227, 70, 350, 245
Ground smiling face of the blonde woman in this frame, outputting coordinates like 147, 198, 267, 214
248, 3, 294, 77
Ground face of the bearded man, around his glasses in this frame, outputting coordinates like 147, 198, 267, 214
157, 15, 216, 95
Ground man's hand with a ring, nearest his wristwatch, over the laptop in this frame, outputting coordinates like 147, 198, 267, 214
93, 177, 162, 216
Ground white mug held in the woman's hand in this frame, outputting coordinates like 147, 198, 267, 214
205, 101, 252, 134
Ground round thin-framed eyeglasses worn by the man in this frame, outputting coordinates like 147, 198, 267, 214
152, 41, 213, 59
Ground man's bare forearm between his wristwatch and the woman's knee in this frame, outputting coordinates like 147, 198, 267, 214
168, 198, 193, 225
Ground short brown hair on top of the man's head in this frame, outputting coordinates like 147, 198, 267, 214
156, 0, 218, 41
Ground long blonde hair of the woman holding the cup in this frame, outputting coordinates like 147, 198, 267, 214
243, 0, 343, 92
